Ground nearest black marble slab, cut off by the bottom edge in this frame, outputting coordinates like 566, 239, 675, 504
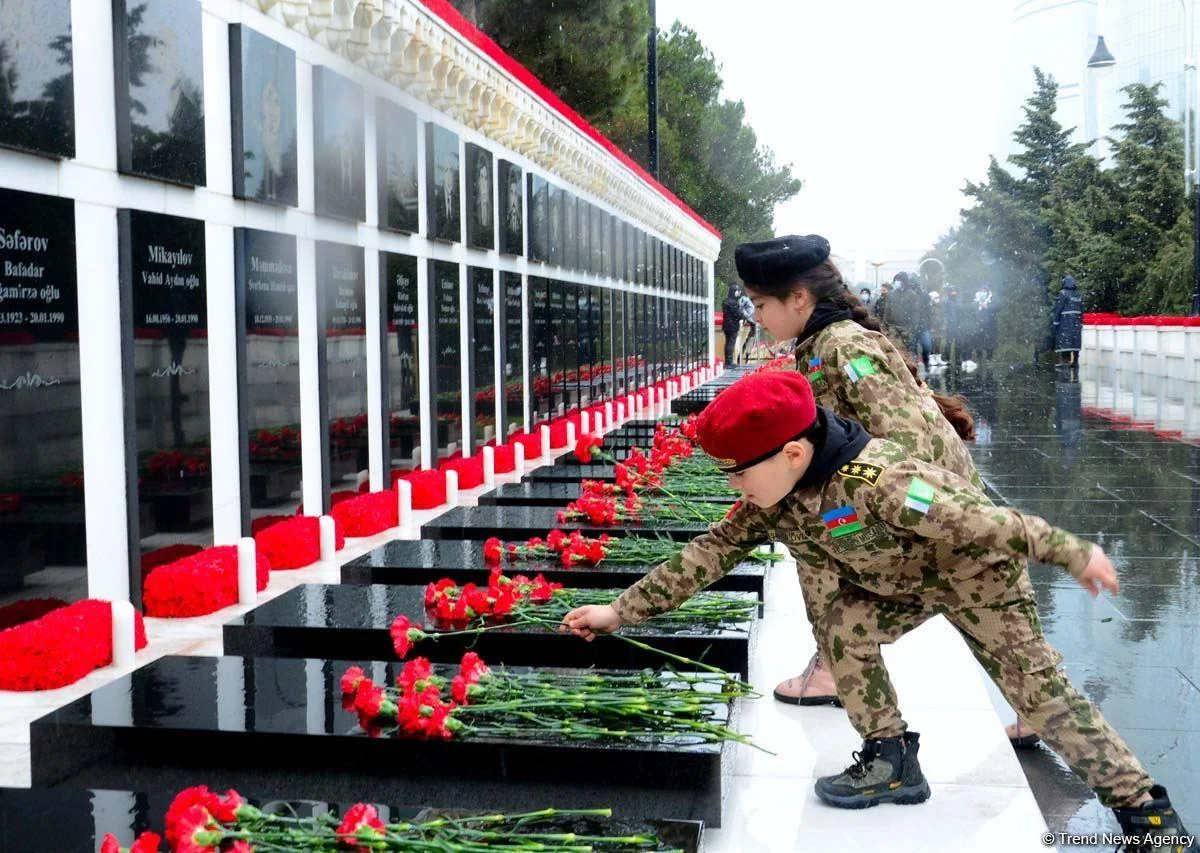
0, 779, 703, 853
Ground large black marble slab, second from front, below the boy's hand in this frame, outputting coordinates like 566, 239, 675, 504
29, 655, 737, 825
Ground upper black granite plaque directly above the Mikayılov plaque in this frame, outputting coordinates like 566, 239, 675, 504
113, 0, 205, 186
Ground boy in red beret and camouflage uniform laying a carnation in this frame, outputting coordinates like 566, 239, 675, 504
563, 372, 1190, 849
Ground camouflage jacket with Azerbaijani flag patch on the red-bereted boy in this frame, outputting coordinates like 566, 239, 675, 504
613, 438, 1092, 624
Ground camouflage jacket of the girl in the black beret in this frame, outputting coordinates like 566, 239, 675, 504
796, 320, 983, 488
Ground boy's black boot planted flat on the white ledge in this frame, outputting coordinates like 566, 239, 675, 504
816, 732, 929, 809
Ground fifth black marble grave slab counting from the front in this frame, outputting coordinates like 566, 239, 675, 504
421, 506, 708, 542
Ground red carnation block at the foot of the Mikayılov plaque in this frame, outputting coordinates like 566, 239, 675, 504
142, 545, 271, 618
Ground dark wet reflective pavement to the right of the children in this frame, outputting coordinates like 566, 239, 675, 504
930, 365, 1200, 851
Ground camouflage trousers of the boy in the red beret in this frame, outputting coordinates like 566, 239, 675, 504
815, 577, 1153, 806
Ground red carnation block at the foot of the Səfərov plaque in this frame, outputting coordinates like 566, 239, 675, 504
0, 599, 146, 690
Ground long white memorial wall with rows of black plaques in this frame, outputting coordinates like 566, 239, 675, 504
0, 0, 720, 605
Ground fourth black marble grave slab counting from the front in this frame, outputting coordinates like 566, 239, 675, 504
342, 539, 767, 601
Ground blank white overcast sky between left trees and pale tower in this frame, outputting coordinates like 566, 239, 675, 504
658, 0, 1013, 273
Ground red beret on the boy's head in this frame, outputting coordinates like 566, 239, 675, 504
696, 371, 817, 473
